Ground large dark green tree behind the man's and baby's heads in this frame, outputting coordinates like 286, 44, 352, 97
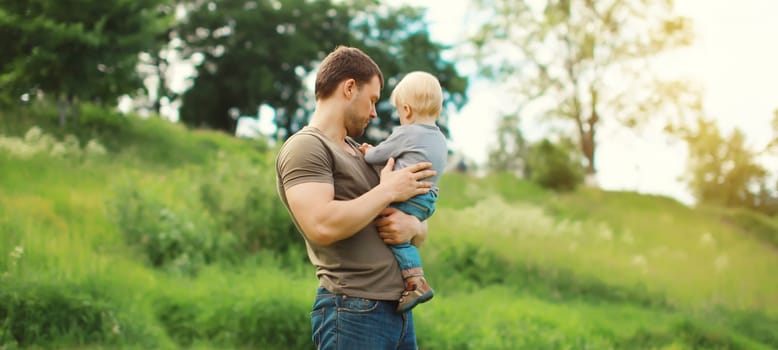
174, 0, 467, 142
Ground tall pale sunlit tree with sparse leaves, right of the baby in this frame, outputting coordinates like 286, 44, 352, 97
470, 0, 691, 179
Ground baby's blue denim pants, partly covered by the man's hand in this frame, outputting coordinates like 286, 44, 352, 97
389, 192, 438, 270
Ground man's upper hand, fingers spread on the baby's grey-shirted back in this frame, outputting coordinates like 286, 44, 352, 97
377, 158, 437, 202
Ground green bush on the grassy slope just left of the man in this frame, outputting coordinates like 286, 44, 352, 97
111, 151, 303, 275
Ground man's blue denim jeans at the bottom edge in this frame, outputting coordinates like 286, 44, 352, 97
311, 287, 417, 350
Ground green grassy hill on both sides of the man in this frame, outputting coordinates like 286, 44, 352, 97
0, 106, 778, 349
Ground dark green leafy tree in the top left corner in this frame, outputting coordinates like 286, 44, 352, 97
0, 0, 171, 125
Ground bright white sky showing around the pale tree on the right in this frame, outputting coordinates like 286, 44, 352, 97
395, 0, 778, 204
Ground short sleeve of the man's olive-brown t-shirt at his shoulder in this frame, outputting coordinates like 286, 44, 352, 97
276, 134, 334, 190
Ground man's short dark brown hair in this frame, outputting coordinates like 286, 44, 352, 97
314, 45, 384, 100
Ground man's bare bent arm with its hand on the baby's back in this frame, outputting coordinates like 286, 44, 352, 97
285, 159, 435, 246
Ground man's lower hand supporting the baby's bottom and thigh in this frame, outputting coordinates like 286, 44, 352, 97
375, 208, 427, 247
